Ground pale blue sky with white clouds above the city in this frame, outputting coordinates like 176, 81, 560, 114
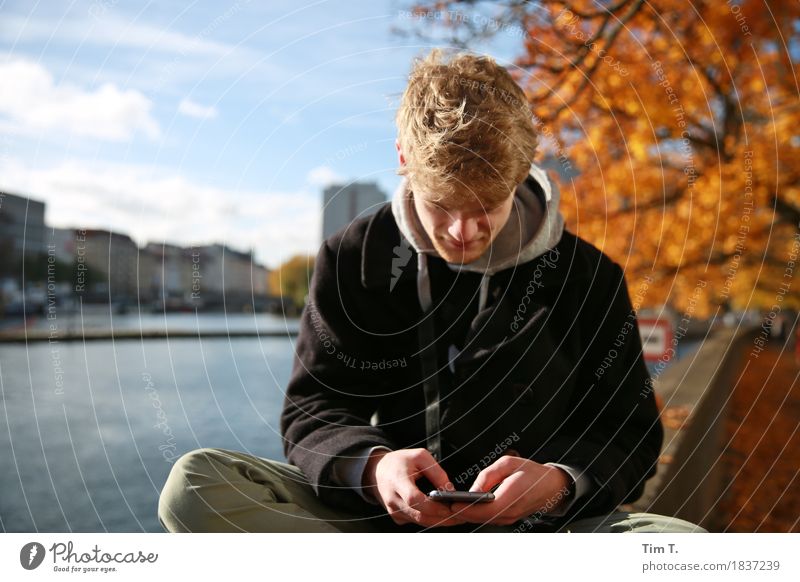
0, 0, 522, 268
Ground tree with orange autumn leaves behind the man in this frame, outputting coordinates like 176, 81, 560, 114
400, 0, 800, 317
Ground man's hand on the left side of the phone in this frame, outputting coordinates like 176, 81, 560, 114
362, 449, 466, 527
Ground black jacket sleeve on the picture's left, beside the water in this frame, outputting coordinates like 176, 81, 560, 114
281, 242, 400, 506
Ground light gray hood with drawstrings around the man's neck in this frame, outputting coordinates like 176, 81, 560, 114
392, 164, 564, 318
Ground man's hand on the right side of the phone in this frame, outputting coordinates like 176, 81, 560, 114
451, 455, 571, 525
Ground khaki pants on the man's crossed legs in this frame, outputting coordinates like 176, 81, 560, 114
158, 448, 705, 533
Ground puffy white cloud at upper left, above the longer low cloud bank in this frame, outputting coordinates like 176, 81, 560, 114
0, 58, 161, 141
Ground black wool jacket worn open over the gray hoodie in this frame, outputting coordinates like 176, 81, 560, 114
281, 204, 663, 521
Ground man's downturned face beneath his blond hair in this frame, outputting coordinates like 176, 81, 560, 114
414, 191, 514, 263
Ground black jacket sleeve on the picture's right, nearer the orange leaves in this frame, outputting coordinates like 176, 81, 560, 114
535, 262, 664, 519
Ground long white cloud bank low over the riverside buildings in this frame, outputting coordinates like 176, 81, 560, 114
0, 159, 321, 267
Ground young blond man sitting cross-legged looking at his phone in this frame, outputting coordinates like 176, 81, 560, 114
159, 51, 703, 531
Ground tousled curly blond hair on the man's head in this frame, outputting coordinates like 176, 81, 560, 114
396, 49, 537, 206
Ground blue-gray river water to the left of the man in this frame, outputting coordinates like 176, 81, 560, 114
0, 314, 297, 532
